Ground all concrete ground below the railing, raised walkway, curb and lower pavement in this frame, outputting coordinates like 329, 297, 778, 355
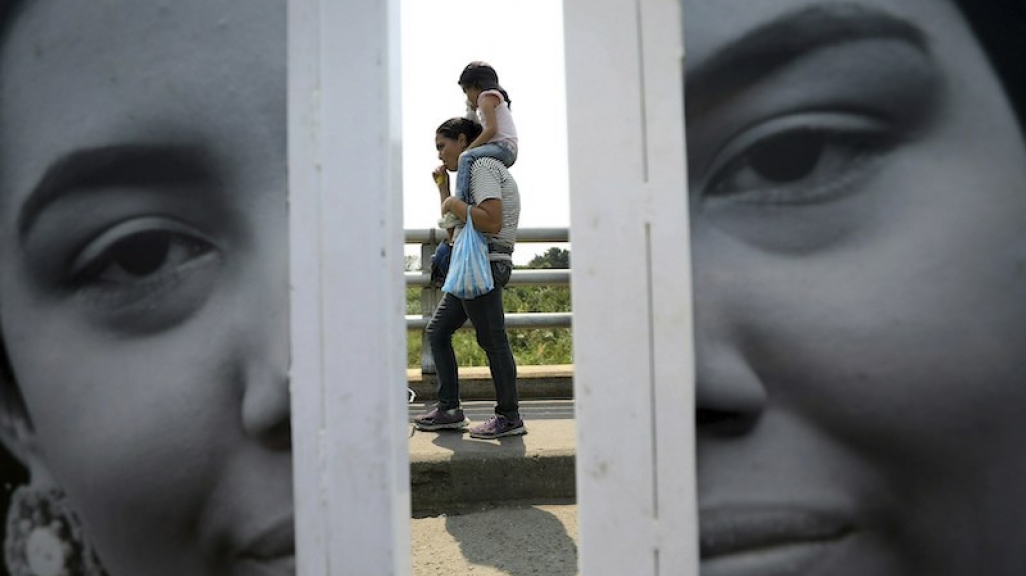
408, 377, 578, 576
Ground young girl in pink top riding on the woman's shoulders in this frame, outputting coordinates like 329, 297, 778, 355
456, 62, 517, 204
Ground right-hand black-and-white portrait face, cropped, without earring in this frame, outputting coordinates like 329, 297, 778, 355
684, 0, 1026, 576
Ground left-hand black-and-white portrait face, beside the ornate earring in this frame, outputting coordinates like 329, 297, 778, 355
0, 0, 294, 576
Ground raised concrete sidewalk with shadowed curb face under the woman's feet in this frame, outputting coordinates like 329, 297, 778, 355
409, 400, 576, 516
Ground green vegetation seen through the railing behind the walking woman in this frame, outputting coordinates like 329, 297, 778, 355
406, 247, 573, 368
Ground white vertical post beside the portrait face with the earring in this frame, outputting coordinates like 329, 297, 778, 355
288, 0, 409, 576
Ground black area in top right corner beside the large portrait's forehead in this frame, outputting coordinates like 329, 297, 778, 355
957, 0, 1026, 131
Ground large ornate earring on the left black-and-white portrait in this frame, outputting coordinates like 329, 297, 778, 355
3, 486, 107, 576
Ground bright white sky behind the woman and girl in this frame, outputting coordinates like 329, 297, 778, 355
400, 0, 569, 264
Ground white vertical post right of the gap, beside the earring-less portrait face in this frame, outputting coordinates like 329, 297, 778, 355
564, 0, 698, 576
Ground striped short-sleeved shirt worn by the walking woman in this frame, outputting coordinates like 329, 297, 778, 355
452, 157, 520, 260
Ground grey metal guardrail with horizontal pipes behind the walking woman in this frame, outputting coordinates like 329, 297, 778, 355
404, 228, 573, 374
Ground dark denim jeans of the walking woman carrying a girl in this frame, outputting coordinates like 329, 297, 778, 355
427, 262, 520, 420
